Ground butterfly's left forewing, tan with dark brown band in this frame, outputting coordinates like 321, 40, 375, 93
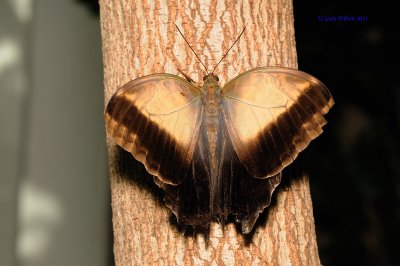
105, 74, 203, 184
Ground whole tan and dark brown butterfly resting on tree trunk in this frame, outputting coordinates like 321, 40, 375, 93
105, 28, 334, 234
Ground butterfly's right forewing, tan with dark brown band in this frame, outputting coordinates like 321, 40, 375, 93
222, 67, 334, 178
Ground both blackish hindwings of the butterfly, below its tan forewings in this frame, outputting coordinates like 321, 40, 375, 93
158, 107, 281, 234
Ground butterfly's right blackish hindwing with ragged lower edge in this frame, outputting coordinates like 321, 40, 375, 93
211, 114, 281, 234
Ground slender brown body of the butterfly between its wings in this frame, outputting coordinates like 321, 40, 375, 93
202, 74, 222, 216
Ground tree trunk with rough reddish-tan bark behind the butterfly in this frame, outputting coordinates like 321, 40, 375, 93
100, 0, 320, 265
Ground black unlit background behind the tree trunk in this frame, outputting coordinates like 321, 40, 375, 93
79, 0, 400, 265
